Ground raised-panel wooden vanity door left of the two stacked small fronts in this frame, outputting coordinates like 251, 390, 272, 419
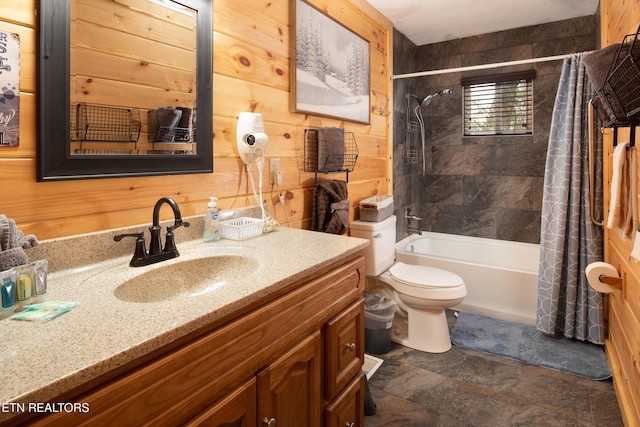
257, 331, 322, 427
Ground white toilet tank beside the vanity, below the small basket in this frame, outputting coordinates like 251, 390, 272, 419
349, 215, 396, 276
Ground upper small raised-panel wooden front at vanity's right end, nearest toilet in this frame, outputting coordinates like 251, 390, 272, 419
325, 299, 364, 401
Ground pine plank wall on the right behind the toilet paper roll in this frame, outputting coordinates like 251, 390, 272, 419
600, 0, 640, 426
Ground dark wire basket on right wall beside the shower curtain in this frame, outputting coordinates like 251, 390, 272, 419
594, 26, 640, 127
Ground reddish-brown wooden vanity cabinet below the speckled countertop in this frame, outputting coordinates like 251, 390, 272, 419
21, 252, 364, 427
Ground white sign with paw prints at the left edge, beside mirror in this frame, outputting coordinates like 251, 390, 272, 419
0, 30, 20, 147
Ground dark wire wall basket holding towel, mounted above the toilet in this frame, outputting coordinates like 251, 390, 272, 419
304, 129, 358, 183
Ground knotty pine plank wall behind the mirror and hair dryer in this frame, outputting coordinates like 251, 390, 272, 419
0, 0, 393, 240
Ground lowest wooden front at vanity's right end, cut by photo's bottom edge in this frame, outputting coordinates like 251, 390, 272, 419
326, 372, 364, 427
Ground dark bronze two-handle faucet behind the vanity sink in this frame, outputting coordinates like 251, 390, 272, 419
113, 197, 189, 267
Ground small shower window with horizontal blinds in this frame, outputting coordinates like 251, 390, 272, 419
462, 71, 536, 136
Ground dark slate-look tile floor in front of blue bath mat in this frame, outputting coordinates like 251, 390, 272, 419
364, 310, 623, 427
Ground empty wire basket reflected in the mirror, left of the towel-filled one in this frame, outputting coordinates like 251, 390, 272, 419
70, 102, 141, 143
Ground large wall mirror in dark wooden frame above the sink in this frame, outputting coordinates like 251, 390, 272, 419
37, 0, 213, 181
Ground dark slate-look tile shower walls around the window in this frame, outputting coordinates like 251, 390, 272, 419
393, 16, 597, 243
